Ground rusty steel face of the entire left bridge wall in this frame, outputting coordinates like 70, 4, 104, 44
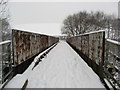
12, 30, 59, 65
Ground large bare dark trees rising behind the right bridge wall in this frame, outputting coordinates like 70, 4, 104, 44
61, 11, 119, 39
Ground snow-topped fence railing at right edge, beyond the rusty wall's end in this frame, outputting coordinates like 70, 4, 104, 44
104, 39, 120, 89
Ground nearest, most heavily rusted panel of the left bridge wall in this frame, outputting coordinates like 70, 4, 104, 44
13, 31, 30, 65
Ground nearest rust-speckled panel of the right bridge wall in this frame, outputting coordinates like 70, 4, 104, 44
89, 32, 104, 65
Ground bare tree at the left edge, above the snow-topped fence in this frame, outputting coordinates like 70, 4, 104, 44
0, 0, 11, 41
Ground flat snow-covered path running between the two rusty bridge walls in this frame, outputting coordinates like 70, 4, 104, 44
5, 41, 104, 88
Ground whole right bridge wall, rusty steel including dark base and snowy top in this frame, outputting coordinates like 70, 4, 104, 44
67, 31, 105, 77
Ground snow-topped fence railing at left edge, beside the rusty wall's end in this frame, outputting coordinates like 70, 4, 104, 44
0, 40, 12, 84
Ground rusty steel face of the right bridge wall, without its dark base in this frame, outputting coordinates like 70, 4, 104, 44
67, 31, 105, 65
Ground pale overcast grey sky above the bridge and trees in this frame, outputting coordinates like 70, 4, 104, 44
9, 2, 118, 34
